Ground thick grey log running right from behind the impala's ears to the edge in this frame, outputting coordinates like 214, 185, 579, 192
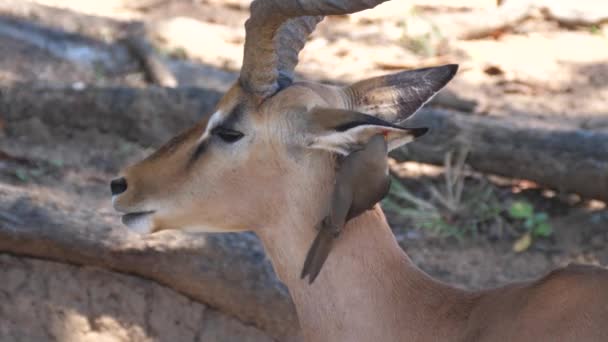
392, 109, 608, 201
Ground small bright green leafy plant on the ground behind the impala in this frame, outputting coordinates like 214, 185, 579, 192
508, 201, 553, 252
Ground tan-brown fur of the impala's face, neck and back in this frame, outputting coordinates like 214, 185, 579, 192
115, 73, 608, 342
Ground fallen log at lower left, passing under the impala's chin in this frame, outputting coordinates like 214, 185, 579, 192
0, 184, 299, 341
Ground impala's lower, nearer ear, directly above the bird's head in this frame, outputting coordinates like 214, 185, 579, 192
306, 107, 428, 155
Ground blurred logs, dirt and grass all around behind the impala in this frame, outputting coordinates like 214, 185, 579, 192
0, 0, 608, 341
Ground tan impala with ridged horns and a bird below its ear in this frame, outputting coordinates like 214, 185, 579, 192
111, 0, 608, 342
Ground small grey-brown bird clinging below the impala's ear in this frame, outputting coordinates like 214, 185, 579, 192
300, 134, 390, 284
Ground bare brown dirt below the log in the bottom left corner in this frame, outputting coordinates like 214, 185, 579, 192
0, 255, 272, 342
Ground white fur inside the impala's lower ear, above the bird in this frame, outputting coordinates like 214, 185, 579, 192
308, 124, 427, 155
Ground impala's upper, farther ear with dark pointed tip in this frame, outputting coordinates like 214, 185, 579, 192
344, 64, 458, 123
